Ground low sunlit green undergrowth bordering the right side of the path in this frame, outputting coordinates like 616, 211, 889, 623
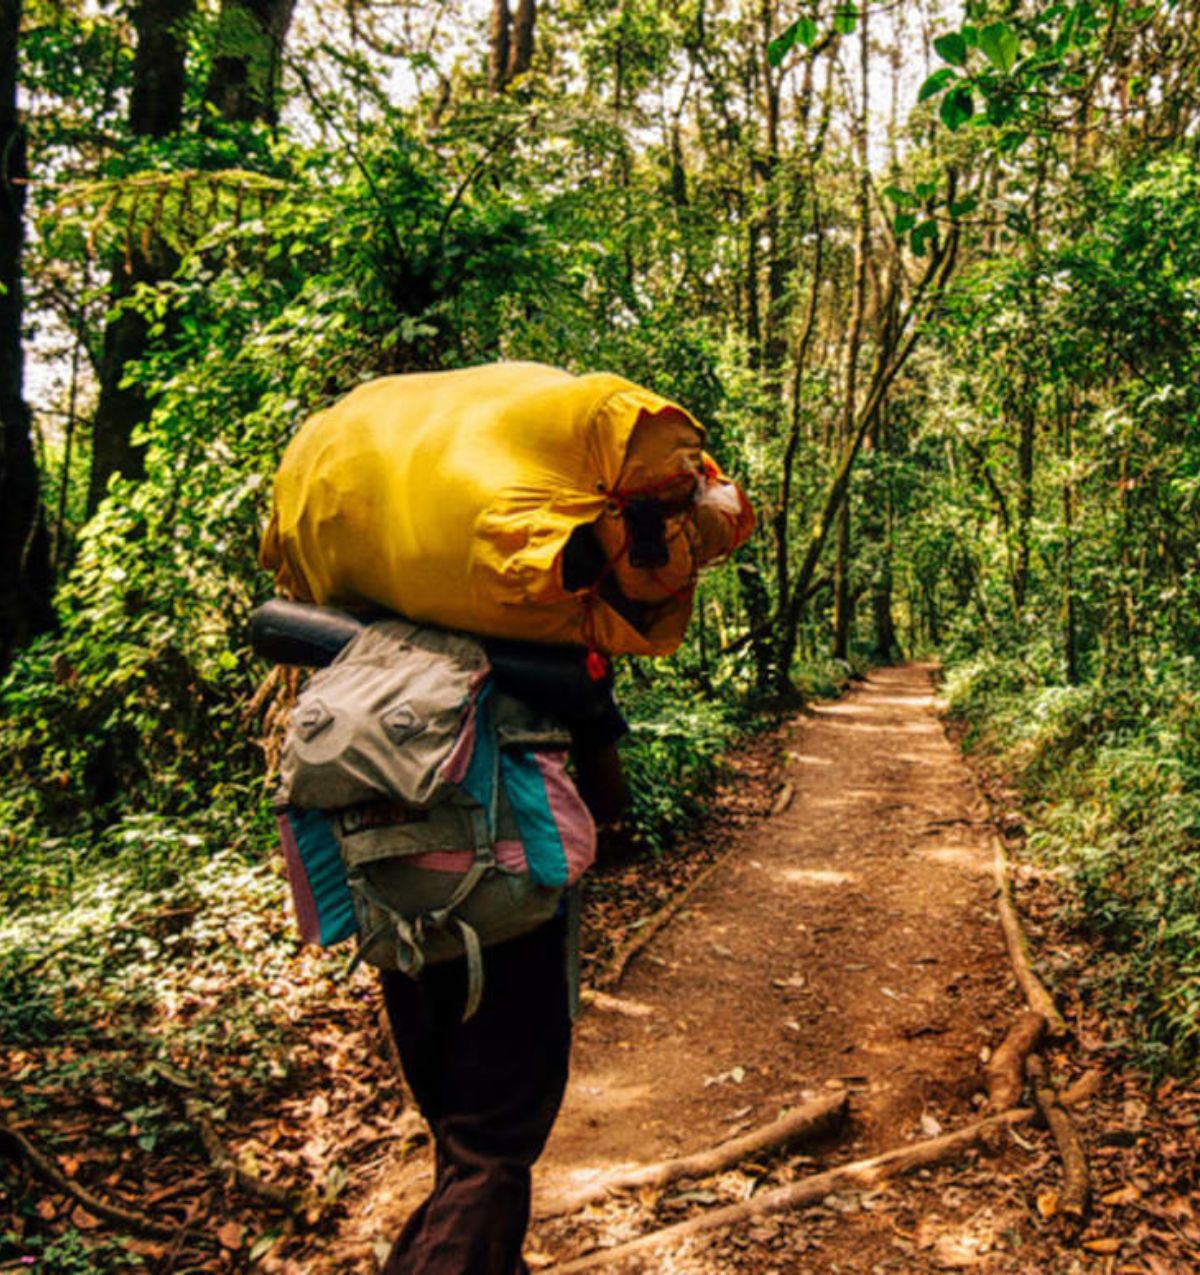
946, 655, 1200, 1074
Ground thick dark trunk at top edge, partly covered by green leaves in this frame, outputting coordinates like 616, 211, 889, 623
204, 0, 296, 125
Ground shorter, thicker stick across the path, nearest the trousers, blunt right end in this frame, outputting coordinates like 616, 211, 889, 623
538, 1094, 849, 1218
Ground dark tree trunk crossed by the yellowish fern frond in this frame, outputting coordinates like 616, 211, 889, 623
88, 0, 191, 516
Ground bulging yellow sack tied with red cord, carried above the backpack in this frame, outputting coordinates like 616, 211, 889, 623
259, 363, 754, 655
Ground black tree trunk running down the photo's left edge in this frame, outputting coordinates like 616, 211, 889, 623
0, 0, 54, 672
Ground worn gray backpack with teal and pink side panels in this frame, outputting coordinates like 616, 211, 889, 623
278, 620, 596, 1017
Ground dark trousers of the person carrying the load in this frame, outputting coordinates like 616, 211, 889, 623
380, 917, 571, 1275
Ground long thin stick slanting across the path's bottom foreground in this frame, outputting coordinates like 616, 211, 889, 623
551, 1107, 1037, 1275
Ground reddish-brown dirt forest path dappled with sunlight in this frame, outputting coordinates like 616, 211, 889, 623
339, 664, 1040, 1275
